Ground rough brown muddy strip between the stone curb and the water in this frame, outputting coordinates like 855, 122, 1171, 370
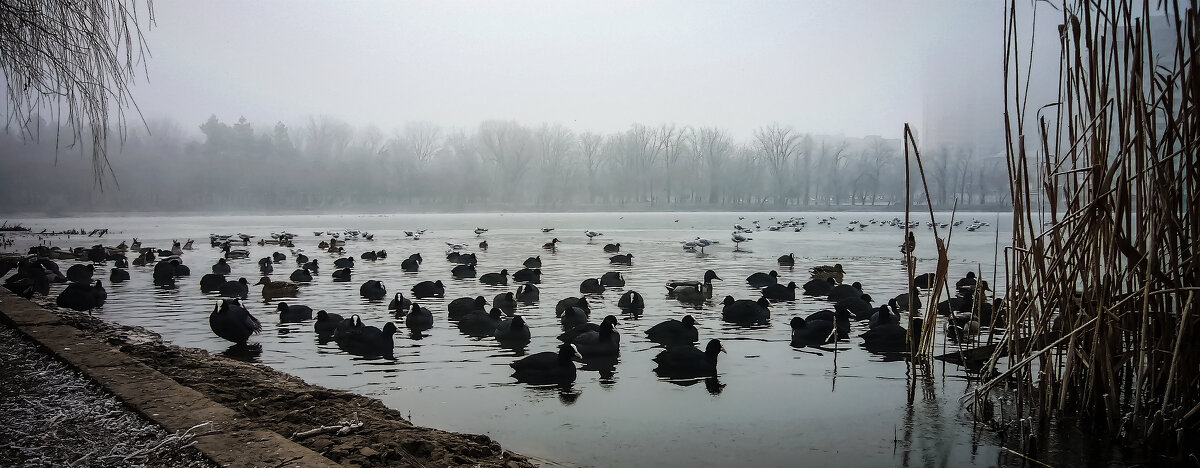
12, 296, 534, 467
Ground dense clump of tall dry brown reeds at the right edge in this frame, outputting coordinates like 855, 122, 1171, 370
969, 0, 1200, 450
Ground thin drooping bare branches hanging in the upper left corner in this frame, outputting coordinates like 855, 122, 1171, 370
0, 0, 154, 190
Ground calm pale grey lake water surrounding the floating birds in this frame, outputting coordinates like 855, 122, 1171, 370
8, 212, 1032, 467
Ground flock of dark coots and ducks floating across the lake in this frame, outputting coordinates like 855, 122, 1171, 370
0, 218, 1003, 383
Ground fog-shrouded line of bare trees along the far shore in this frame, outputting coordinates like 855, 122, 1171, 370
0, 115, 1009, 214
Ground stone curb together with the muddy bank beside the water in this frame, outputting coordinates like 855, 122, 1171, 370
0, 290, 535, 468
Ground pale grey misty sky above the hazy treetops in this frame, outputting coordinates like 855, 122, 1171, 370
134, 0, 1003, 138
